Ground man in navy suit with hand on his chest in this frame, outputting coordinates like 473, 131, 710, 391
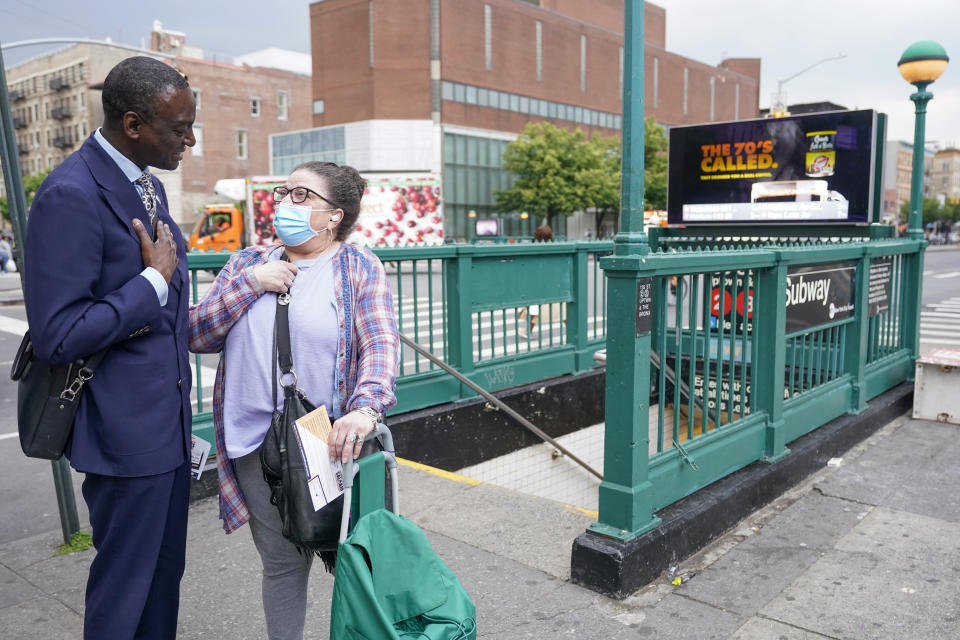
25, 57, 196, 640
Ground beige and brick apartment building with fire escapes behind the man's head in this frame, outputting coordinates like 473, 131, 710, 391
0, 27, 311, 228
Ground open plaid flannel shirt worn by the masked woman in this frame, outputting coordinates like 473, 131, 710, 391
190, 243, 400, 533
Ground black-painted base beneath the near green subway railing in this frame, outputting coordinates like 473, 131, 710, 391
570, 382, 913, 600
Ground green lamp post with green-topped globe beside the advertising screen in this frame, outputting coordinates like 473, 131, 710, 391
897, 40, 950, 240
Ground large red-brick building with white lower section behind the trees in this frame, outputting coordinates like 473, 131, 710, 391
271, 0, 760, 237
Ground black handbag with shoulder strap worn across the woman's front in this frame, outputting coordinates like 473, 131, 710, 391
260, 284, 382, 571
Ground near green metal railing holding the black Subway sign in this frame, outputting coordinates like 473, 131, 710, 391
591, 235, 925, 539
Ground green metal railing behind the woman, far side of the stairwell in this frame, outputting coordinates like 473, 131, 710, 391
188, 241, 613, 439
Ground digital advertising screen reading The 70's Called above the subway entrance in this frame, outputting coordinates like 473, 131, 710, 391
667, 110, 877, 225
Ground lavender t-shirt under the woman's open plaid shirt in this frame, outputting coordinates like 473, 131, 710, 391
223, 251, 339, 458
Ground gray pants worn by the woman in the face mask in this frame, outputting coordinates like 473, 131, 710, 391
233, 449, 313, 640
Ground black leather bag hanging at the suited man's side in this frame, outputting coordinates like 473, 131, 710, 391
10, 331, 108, 460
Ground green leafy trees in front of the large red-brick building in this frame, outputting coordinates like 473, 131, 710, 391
494, 116, 667, 229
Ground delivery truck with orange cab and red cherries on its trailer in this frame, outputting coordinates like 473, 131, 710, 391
189, 173, 443, 251
